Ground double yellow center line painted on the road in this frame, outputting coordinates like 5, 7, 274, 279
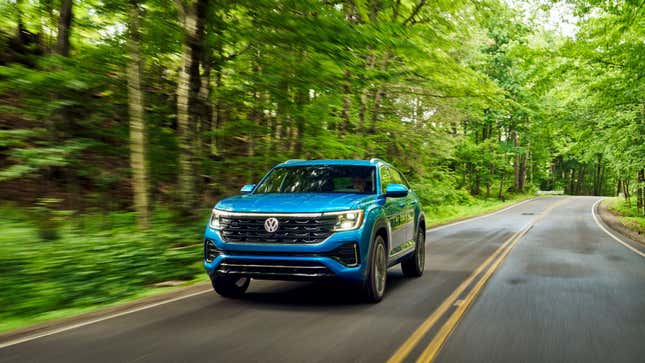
387, 199, 567, 363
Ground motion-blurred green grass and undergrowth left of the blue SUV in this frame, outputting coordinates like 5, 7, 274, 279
0, 206, 207, 331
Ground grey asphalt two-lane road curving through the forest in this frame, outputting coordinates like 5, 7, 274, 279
0, 197, 645, 363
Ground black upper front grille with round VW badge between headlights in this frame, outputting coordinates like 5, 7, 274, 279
220, 216, 337, 244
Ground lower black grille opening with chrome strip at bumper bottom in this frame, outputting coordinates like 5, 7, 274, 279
217, 259, 334, 280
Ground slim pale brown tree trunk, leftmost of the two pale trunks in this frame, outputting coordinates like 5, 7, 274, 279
127, 0, 150, 229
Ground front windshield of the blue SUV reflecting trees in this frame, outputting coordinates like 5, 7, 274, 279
255, 165, 375, 194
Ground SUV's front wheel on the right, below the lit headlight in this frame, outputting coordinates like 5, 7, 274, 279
363, 235, 387, 303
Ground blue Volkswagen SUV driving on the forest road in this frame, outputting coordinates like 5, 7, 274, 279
204, 159, 425, 302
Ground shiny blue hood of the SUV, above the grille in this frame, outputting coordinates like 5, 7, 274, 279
215, 193, 374, 213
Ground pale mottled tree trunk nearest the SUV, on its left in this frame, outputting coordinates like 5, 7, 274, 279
177, 0, 208, 215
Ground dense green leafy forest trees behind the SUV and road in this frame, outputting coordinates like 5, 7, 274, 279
0, 0, 645, 228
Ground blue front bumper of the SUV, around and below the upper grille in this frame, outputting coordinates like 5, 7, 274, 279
204, 223, 371, 282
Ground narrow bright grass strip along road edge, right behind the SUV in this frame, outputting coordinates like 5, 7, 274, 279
424, 194, 535, 228
